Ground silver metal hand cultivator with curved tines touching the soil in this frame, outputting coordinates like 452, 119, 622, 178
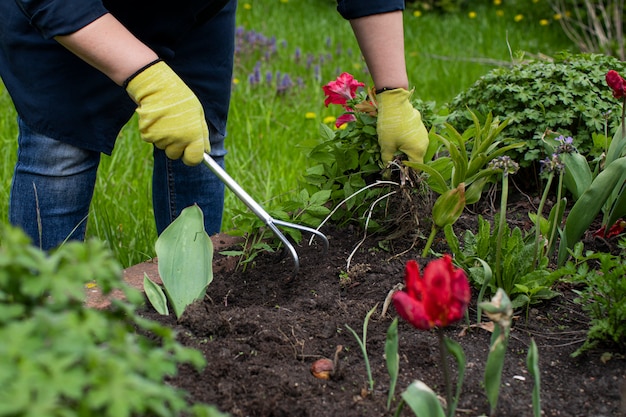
204, 152, 328, 276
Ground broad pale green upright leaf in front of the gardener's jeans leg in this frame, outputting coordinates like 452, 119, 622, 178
155, 205, 213, 318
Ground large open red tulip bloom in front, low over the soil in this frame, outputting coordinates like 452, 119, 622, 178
393, 255, 470, 330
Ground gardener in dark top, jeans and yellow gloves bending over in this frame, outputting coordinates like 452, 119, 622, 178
0, 0, 427, 250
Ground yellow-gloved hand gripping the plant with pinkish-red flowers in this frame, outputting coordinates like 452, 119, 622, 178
376, 88, 428, 164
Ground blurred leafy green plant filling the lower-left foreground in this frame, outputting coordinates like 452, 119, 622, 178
0, 226, 225, 417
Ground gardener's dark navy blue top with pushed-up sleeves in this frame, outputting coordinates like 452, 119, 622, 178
0, 0, 404, 154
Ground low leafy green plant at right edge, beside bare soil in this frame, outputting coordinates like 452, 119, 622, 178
553, 242, 626, 356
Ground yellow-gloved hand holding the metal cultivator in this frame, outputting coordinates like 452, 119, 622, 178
125, 61, 211, 165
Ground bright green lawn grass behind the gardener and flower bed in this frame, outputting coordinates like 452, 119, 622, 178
0, 0, 571, 266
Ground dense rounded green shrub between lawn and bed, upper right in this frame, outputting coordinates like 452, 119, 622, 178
448, 53, 626, 167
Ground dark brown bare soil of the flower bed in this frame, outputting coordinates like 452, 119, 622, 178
138, 189, 626, 417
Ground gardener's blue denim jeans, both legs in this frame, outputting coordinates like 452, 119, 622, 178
9, 119, 226, 250
